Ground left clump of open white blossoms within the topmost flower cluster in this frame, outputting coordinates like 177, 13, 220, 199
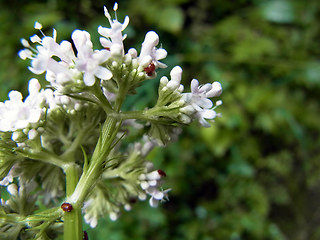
19, 24, 112, 89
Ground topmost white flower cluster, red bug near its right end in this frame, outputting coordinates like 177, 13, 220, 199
19, 3, 167, 92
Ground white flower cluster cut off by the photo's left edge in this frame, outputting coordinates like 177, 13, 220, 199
0, 78, 83, 142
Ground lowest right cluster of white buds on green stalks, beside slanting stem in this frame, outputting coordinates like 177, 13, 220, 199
83, 136, 171, 228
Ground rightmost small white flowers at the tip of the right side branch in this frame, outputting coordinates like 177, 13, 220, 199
180, 79, 222, 127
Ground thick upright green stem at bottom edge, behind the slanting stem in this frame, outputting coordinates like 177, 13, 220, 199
64, 163, 83, 240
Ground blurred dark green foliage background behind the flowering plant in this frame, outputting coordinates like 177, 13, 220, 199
0, 0, 320, 240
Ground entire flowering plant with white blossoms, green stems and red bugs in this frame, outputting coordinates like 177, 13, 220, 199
0, 3, 222, 240
